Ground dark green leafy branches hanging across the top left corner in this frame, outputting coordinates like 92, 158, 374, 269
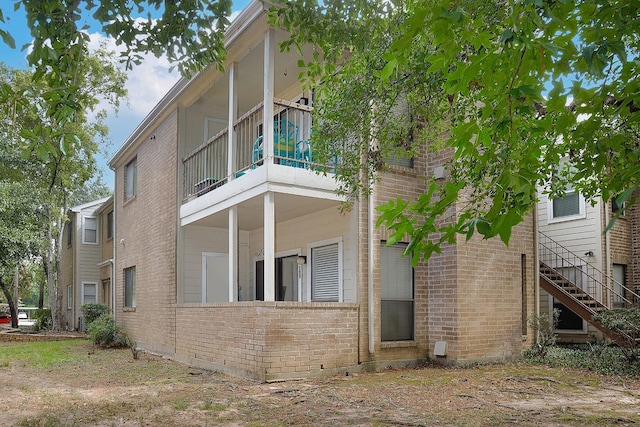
0, 0, 231, 163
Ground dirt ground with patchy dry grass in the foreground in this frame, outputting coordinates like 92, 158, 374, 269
0, 341, 640, 426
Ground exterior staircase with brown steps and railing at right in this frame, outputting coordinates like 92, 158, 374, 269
538, 233, 640, 347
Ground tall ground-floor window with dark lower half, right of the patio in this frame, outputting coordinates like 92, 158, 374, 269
380, 242, 414, 341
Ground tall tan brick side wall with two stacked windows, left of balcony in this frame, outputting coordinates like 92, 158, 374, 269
115, 110, 178, 353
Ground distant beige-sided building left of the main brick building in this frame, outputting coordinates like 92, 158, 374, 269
61, 197, 114, 330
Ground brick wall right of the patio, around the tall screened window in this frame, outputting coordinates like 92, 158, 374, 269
360, 143, 537, 363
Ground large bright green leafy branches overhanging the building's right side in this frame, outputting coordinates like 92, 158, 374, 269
270, 0, 640, 261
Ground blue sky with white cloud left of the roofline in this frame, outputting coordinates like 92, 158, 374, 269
0, 0, 249, 187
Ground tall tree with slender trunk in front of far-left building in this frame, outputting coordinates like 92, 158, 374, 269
0, 50, 126, 329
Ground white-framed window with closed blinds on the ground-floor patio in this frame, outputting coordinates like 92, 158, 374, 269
309, 242, 342, 302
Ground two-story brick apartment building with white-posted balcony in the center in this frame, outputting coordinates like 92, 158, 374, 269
107, 1, 536, 380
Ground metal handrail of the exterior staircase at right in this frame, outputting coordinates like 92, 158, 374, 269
538, 231, 640, 309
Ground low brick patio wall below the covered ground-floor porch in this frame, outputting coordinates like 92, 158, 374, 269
175, 301, 358, 381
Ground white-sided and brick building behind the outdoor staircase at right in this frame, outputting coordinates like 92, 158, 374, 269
537, 189, 640, 342
